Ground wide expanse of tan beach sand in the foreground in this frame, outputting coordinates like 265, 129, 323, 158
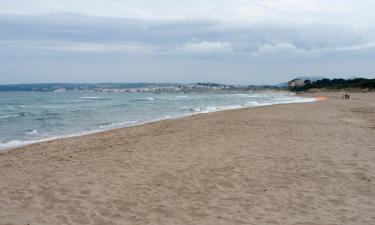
0, 93, 375, 225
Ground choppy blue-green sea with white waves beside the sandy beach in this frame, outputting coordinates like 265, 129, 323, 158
0, 92, 315, 149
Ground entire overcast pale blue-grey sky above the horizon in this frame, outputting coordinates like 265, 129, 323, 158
0, 0, 375, 84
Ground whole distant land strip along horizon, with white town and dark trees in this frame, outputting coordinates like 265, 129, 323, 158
0, 77, 375, 93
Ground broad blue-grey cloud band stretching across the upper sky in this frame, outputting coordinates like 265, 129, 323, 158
0, 15, 375, 54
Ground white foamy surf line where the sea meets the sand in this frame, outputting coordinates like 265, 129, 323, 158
0, 96, 319, 153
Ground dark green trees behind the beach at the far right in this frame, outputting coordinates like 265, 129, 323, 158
290, 78, 375, 92
